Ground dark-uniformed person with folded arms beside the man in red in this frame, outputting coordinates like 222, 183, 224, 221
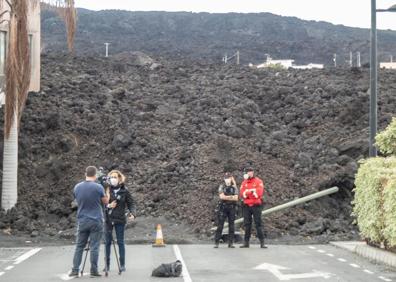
214, 173, 238, 248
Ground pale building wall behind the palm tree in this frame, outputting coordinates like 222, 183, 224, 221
0, 0, 41, 91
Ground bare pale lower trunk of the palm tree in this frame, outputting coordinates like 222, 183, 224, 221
1, 114, 18, 210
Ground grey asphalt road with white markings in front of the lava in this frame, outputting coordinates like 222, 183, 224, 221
0, 245, 396, 282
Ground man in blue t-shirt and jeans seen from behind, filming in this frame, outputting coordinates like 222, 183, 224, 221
69, 166, 109, 277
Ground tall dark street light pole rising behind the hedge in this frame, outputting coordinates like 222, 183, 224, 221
369, 0, 377, 157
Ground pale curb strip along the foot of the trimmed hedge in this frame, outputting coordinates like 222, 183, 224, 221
330, 241, 396, 268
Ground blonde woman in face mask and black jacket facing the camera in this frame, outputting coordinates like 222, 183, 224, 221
105, 170, 136, 271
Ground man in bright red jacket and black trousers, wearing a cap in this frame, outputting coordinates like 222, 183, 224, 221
239, 167, 267, 248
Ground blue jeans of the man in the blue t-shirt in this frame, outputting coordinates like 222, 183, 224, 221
72, 219, 103, 273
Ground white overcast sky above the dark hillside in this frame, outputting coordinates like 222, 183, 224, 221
75, 0, 396, 30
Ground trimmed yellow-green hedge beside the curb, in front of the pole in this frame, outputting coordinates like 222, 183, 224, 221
352, 157, 396, 243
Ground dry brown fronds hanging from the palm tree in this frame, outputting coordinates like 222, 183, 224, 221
0, 0, 76, 138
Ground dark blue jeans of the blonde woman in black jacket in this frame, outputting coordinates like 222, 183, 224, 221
105, 223, 125, 266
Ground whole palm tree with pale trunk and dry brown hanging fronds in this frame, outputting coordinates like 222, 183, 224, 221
0, 0, 76, 210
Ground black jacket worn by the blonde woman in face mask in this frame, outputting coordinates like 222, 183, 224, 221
106, 183, 136, 224
